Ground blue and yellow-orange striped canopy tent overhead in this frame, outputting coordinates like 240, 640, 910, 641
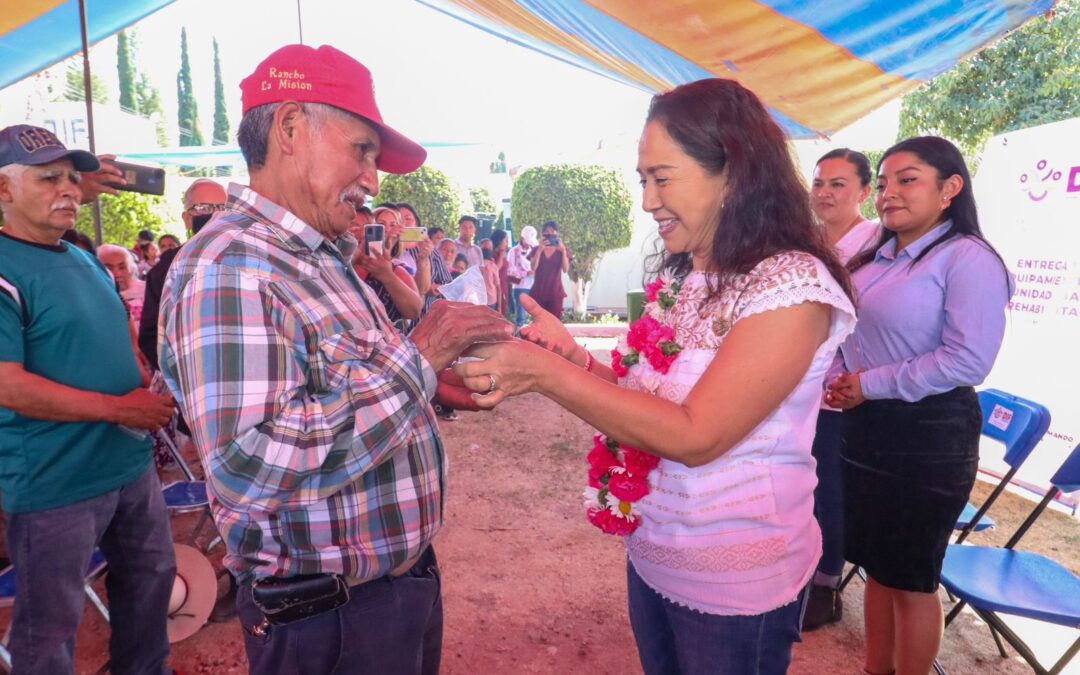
0, 0, 1054, 236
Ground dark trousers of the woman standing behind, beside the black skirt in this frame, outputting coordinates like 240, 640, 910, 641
811, 410, 845, 577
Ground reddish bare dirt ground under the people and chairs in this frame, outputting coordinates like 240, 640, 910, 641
10, 371, 1080, 675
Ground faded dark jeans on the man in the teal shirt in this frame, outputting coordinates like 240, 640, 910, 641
8, 462, 176, 675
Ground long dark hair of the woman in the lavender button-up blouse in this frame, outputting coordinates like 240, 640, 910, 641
848, 136, 1009, 286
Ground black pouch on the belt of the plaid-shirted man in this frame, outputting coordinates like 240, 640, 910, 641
252, 575, 349, 625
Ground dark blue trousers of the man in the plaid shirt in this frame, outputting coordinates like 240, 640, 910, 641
237, 548, 443, 675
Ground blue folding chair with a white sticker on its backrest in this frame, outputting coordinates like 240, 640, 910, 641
956, 389, 1050, 543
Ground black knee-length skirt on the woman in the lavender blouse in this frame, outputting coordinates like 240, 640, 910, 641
841, 387, 983, 593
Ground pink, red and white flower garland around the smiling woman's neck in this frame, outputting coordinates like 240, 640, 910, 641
584, 271, 683, 537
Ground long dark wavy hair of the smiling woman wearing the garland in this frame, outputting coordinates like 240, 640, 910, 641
646, 79, 852, 297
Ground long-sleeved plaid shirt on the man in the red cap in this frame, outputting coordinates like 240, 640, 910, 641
158, 185, 446, 581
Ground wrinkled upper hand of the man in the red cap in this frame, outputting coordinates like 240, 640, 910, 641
409, 301, 514, 372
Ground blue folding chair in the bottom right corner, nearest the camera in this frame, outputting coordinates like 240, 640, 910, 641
935, 445, 1080, 675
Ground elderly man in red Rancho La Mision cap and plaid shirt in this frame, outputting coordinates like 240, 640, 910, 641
159, 45, 512, 675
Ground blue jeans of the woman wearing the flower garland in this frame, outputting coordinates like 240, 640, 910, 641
626, 562, 809, 675
